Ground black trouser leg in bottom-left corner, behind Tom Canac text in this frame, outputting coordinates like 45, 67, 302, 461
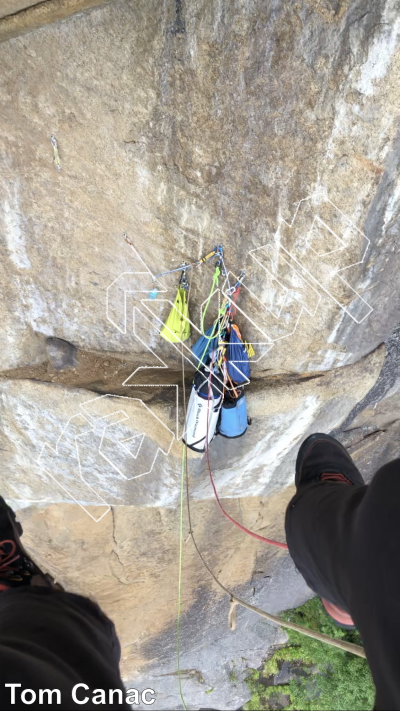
0, 587, 131, 711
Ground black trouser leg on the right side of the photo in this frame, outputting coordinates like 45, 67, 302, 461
285, 459, 400, 711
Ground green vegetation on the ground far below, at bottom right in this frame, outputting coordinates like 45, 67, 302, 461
244, 598, 375, 711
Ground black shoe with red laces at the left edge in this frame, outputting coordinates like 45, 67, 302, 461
0, 496, 62, 593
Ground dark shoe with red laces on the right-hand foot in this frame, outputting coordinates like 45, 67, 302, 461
295, 432, 364, 488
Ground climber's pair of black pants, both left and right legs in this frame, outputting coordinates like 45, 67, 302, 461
0, 460, 400, 711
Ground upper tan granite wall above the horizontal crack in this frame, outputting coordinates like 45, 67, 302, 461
0, 0, 399, 372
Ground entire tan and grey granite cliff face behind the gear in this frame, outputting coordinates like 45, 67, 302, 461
0, 0, 400, 709
